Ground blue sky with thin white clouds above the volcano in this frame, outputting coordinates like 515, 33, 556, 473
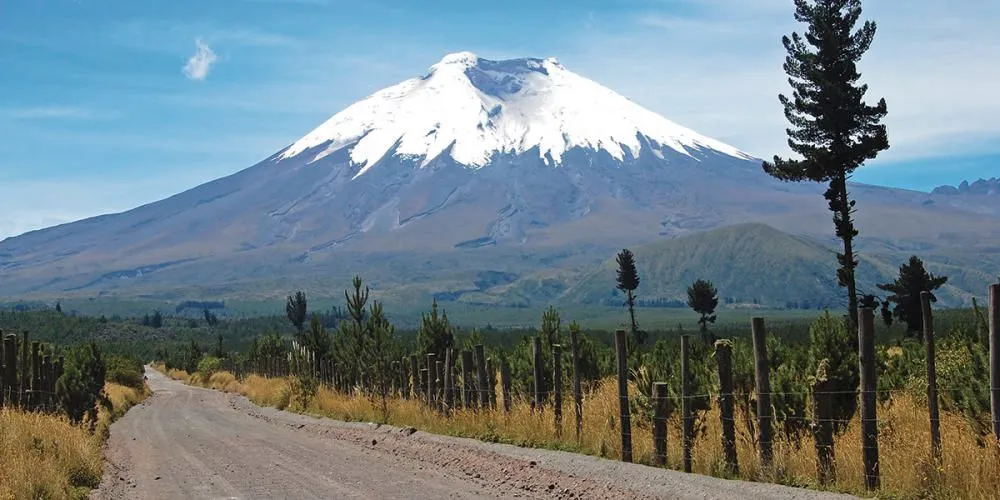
0, 0, 1000, 238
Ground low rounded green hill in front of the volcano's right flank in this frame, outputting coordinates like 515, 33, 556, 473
472, 223, 1000, 308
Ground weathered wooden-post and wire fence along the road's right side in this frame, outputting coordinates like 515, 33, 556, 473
213, 285, 1000, 490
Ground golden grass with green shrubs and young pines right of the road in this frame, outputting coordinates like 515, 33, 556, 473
155, 258, 1000, 498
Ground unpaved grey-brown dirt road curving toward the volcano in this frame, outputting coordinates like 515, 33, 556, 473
91, 369, 847, 499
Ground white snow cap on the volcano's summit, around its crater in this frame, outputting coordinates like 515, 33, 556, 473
281, 52, 751, 175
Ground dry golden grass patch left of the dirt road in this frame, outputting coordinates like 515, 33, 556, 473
0, 383, 148, 499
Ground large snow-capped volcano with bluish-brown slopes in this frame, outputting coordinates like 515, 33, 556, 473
0, 53, 1000, 300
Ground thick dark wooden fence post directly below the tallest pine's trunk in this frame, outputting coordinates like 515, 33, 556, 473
858, 307, 880, 490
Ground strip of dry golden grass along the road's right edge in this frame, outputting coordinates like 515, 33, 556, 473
152, 366, 1000, 499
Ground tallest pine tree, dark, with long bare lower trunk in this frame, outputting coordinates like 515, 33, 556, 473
763, 0, 889, 324
